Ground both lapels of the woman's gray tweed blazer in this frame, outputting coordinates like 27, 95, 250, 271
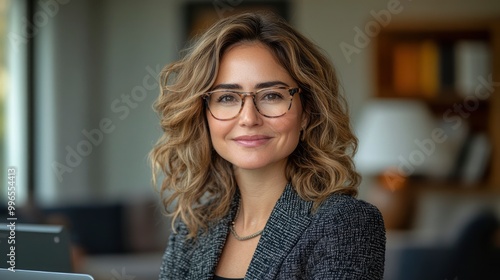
190, 184, 312, 279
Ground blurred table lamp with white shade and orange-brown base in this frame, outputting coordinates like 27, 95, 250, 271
354, 99, 451, 229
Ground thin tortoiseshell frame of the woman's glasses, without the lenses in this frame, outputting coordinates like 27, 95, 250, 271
202, 86, 301, 121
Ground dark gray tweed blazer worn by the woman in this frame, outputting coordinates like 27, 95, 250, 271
160, 187, 385, 280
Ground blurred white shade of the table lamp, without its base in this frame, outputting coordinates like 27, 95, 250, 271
354, 99, 453, 177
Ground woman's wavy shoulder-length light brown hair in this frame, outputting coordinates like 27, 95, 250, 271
150, 10, 360, 238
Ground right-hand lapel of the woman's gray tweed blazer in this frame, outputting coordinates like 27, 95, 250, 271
245, 186, 312, 279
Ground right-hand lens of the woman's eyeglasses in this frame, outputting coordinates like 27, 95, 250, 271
255, 88, 292, 117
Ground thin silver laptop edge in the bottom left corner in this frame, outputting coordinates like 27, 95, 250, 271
0, 268, 94, 280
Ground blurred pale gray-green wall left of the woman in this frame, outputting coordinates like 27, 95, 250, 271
35, 0, 181, 203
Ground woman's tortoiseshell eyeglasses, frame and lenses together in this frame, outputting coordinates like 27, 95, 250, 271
203, 86, 300, 121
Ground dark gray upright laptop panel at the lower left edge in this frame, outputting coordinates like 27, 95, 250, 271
0, 223, 73, 274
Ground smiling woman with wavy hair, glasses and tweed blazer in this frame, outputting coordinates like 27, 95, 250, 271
151, 13, 385, 279
